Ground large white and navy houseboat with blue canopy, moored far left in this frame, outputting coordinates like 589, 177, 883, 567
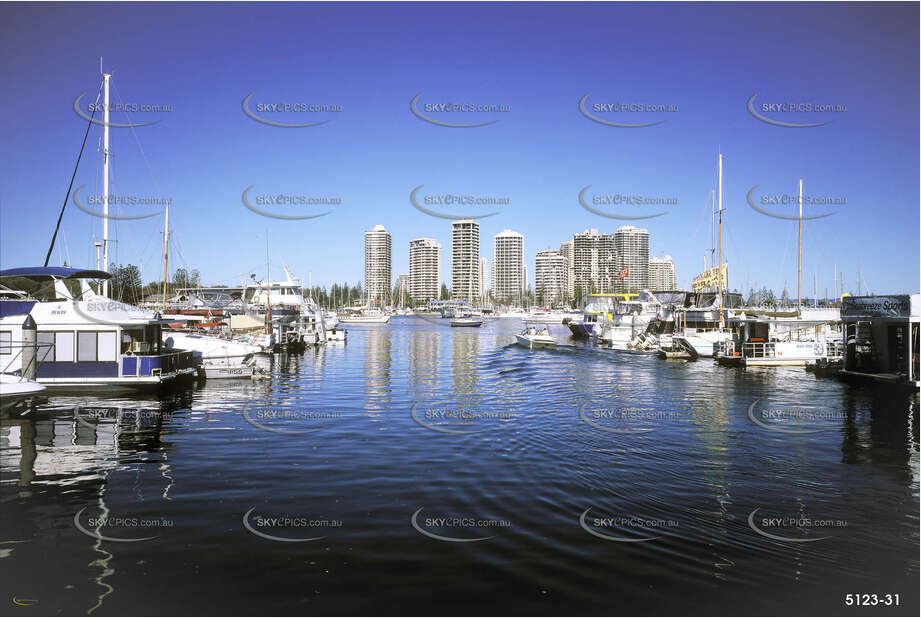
0, 267, 197, 391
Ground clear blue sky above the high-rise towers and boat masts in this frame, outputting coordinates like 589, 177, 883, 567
0, 2, 919, 294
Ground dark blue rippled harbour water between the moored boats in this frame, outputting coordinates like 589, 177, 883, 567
0, 318, 919, 615
